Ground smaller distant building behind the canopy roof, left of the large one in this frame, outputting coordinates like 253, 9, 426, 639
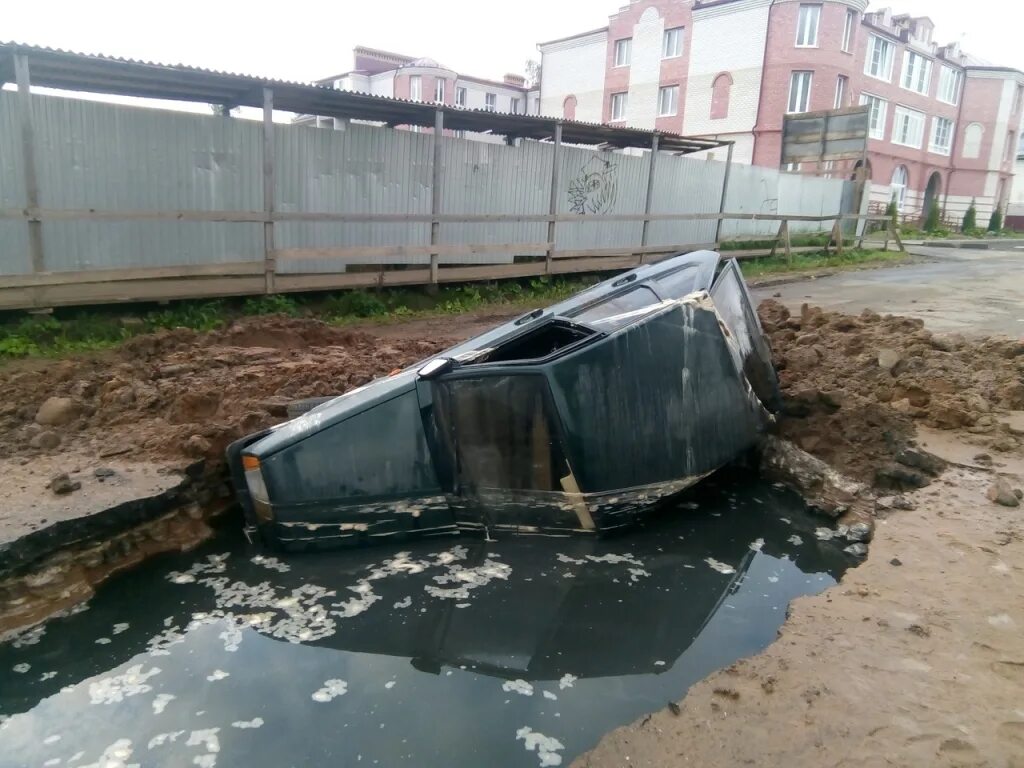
295, 45, 540, 141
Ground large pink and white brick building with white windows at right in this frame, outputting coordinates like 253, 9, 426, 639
539, 0, 1024, 220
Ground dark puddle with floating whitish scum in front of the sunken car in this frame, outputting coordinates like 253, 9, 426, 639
0, 484, 853, 768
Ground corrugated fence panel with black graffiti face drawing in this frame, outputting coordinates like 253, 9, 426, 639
555, 146, 648, 251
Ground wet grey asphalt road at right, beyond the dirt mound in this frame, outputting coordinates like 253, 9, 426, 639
754, 243, 1024, 338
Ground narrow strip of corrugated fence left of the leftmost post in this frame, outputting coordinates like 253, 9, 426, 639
0, 90, 32, 274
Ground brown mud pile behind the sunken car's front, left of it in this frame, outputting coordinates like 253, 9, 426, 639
0, 316, 452, 470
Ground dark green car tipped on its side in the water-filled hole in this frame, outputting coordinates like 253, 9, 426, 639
227, 251, 778, 547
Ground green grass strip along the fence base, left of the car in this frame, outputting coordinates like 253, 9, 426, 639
0, 276, 599, 360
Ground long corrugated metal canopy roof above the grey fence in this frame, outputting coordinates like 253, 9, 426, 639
0, 43, 729, 155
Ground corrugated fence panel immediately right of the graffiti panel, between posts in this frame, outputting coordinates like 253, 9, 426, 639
647, 154, 726, 246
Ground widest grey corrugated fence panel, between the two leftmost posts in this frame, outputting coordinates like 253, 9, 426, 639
33, 96, 263, 271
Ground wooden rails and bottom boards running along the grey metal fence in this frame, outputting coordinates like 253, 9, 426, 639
0, 206, 903, 309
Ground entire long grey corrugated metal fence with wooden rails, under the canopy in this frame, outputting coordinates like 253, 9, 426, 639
0, 91, 856, 308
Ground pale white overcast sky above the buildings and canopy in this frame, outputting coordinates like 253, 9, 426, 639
0, 0, 1024, 81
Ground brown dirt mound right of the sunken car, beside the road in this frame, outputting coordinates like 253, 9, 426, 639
758, 299, 1024, 489
